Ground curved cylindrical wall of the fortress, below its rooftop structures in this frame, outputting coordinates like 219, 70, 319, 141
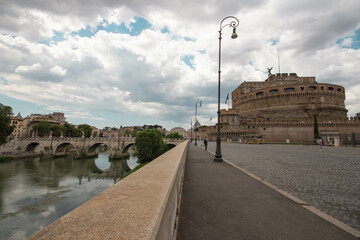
233, 83, 347, 118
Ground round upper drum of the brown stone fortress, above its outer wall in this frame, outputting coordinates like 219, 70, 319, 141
231, 73, 347, 122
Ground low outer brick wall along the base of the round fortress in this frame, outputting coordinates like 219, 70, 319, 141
197, 122, 360, 146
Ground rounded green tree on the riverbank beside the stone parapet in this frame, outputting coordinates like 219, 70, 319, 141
135, 129, 167, 163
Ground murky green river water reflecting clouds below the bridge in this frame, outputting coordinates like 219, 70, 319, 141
0, 146, 137, 240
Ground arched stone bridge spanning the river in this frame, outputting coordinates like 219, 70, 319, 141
0, 137, 184, 158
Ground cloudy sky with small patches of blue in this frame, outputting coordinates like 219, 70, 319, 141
0, 0, 360, 130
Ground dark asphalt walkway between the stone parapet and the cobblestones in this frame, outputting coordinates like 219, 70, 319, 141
178, 143, 357, 240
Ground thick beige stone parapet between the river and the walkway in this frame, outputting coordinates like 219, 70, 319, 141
29, 141, 188, 240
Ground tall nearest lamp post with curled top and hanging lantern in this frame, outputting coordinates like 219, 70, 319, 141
214, 16, 239, 162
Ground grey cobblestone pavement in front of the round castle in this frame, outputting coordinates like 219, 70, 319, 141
208, 142, 360, 230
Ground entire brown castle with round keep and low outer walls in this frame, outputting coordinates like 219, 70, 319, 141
199, 71, 360, 146
